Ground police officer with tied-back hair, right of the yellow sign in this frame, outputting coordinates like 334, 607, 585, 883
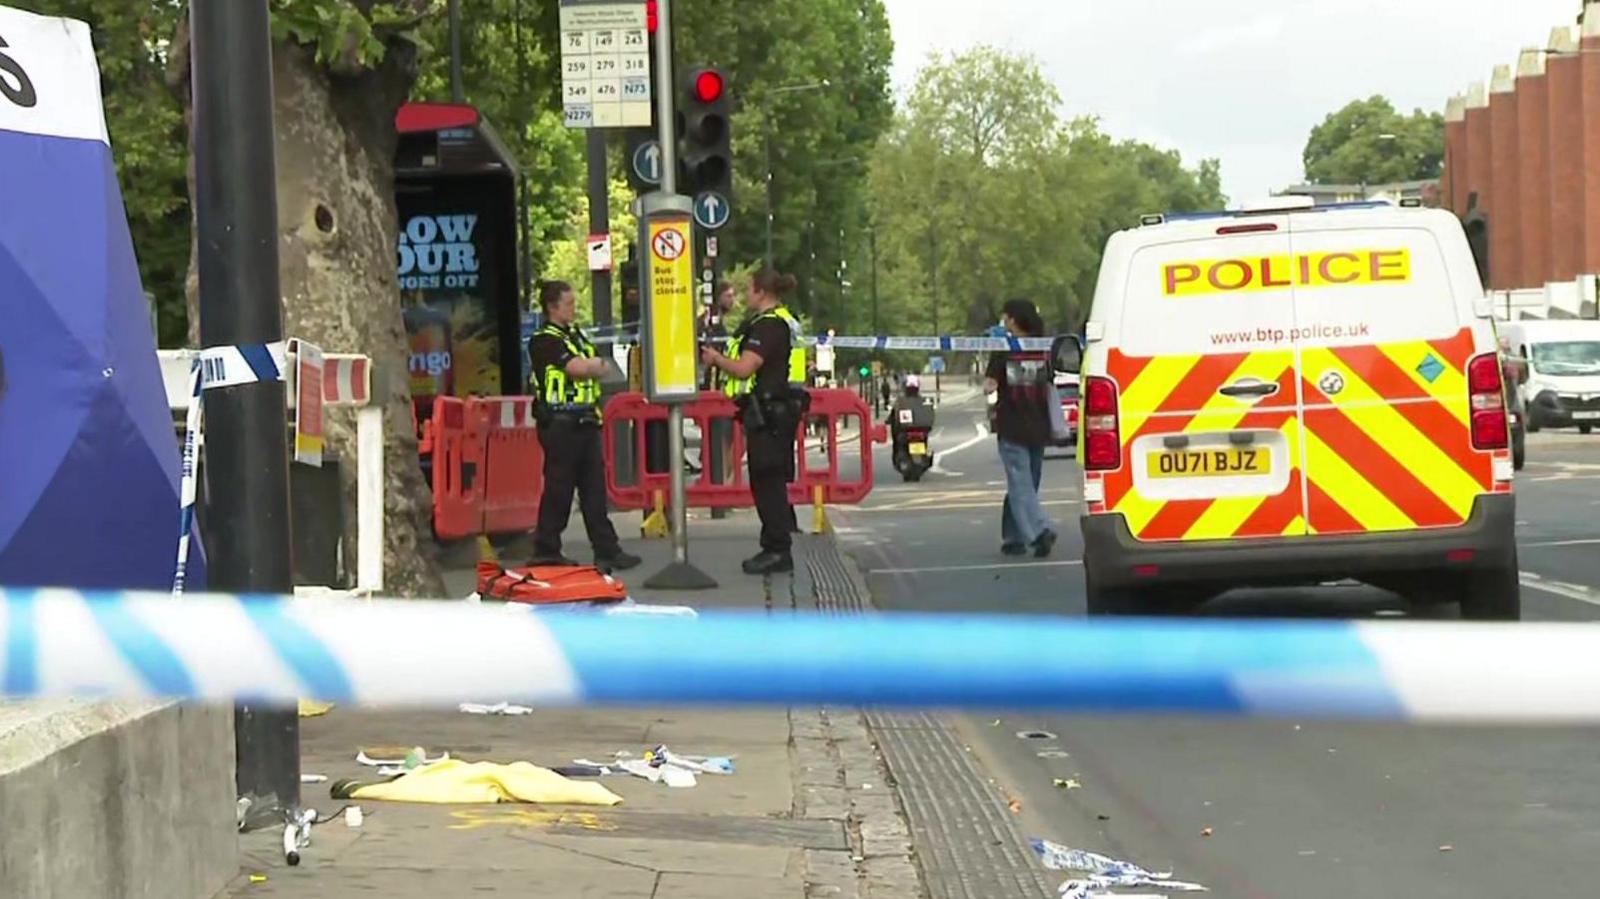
701, 267, 810, 574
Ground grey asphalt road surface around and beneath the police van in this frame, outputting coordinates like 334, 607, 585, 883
835, 390, 1600, 899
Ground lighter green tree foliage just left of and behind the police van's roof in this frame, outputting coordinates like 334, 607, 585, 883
870, 46, 1224, 334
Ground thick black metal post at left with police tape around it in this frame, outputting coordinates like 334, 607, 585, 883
189, 0, 299, 809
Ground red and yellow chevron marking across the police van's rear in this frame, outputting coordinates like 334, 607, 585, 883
1090, 330, 1491, 541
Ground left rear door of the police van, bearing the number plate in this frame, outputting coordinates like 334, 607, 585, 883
1104, 216, 1306, 541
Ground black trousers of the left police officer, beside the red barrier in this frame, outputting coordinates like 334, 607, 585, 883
533, 414, 622, 558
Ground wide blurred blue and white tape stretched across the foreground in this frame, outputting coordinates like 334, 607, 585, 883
0, 590, 1600, 723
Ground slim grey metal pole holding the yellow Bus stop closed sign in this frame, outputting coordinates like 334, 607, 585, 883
640, 0, 717, 590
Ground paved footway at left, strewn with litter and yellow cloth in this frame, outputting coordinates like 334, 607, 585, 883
209, 512, 922, 899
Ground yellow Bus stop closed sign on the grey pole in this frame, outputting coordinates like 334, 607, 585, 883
645, 213, 699, 400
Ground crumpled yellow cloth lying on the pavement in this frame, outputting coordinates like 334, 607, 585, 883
350, 758, 622, 805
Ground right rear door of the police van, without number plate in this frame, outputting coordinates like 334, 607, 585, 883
1290, 214, 1494, 534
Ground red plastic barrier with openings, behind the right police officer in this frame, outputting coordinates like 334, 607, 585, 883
605, 390, 886, 509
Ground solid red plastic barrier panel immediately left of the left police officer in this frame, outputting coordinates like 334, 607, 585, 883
469, 397, 544, 534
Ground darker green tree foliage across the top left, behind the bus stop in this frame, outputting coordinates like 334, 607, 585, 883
21, 0, 893, 339
